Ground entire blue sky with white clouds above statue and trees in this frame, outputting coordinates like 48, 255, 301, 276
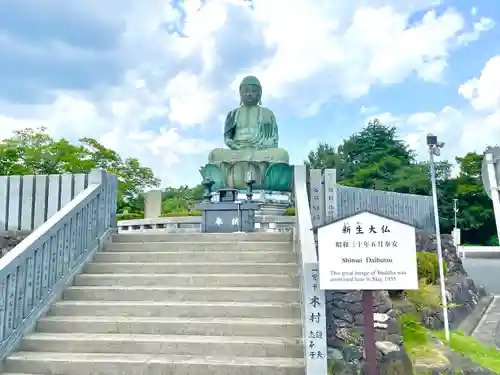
0, 0, 500, 185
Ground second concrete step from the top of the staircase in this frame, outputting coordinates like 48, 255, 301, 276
104, 241, 293, 252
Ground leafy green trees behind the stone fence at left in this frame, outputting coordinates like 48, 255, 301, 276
0, 127, 160, 212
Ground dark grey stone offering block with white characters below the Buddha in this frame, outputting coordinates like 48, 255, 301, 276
196, 203, 259, 233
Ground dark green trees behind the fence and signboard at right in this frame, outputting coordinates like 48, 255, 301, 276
305, 120, 495, 244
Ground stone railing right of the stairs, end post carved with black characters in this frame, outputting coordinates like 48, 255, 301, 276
293, 165, 327, 375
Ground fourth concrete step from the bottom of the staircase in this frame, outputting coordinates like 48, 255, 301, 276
49, 300, 301, 319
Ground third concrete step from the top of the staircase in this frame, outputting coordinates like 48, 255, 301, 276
94, 251, 296, 263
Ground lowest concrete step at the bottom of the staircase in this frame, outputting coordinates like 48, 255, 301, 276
6, 352, 305, 375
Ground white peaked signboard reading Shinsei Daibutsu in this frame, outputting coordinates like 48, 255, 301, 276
318, 212, 418, 290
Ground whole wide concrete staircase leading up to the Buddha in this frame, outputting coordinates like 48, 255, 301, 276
4, 233, 305, 375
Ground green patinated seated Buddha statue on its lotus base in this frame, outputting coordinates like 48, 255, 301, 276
200, 76, 293, 191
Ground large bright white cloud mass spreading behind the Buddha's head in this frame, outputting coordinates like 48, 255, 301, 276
0, 0, 498, 187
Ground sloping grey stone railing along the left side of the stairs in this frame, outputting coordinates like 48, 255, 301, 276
0, 170, 117, 358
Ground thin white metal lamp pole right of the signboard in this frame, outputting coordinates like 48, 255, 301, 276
429, 148, 450, 342
